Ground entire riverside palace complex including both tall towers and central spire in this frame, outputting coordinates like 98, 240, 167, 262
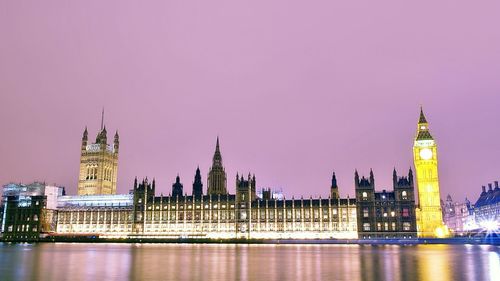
0, 110, 454, 241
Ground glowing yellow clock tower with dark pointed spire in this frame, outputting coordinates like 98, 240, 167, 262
413, 108, 448, 237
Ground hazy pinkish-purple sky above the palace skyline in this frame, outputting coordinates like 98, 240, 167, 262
0, 0, 500, 201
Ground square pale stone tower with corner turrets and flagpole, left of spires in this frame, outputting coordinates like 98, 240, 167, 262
78, 112, 120, 195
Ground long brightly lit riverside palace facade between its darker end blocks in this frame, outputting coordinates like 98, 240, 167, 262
57, 176, 357, 239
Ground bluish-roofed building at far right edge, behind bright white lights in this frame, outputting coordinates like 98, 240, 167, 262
474, 181, 500, 231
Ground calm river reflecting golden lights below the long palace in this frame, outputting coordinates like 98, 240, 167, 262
0, 243, 500, 281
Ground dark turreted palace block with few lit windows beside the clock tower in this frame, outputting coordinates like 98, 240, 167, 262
354, 169, 417, 239
